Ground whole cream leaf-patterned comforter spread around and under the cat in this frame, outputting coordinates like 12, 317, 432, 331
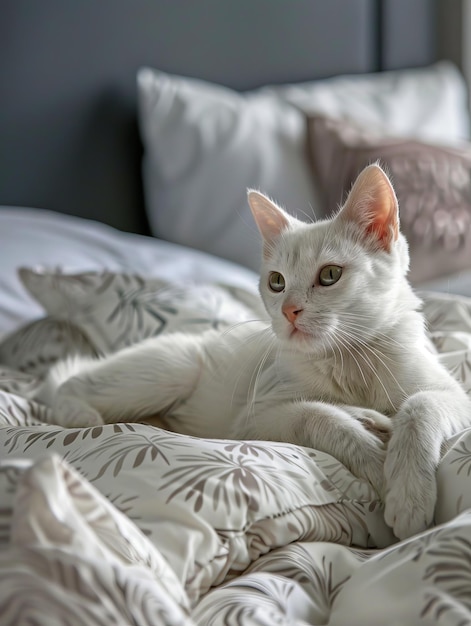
0, 270, 471, 626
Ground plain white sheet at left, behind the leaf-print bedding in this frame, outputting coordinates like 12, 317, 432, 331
0, 207, 258, 334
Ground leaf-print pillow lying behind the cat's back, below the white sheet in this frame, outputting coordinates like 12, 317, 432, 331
19, 268, 266, 353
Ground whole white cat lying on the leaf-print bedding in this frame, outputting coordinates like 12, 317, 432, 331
38, 165, 471, 538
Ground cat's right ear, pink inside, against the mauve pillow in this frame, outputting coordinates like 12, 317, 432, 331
339, 164, 399, 252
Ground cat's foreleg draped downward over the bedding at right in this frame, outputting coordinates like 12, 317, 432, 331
384, 388, 471, 539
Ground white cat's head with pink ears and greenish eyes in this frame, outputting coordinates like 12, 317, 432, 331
248, 165, 414, 353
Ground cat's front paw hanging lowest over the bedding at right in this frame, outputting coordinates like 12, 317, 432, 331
384, 458, 437, 539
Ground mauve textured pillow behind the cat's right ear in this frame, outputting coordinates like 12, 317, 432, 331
309, 115, 471, 284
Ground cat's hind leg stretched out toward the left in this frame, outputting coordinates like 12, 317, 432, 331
43, 333, 207, 427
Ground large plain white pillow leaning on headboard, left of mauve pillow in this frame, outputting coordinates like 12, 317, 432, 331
138, 69, 317, 270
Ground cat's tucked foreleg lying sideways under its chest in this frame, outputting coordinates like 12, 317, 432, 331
233, 401, 385, 496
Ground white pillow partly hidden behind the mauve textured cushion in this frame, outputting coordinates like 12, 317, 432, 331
266, 61, 470, 144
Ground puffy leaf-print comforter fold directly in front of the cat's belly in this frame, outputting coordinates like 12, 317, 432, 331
0, 416, 393, 600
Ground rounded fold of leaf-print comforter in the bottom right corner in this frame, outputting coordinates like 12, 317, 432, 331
329, 511, 471, 626
